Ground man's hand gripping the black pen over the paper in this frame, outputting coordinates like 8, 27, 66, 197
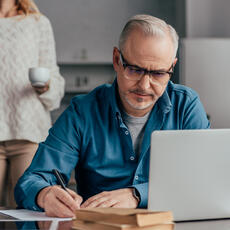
37, 185, 82, 217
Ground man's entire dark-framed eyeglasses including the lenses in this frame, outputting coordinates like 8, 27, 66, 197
119, 51, 174, 85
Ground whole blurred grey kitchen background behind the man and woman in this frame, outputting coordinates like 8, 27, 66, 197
35, 0, 230, 128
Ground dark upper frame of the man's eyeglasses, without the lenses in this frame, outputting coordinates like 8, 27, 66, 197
119, 50, 174, 77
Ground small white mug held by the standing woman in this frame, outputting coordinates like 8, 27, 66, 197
29, 67, 50, 87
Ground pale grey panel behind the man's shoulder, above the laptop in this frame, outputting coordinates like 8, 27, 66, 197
180, 38, 230, 128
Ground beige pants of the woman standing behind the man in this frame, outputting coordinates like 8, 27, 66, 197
0, 140, 38, 208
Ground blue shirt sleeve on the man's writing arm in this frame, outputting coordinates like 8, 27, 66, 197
15, 101, 82, 210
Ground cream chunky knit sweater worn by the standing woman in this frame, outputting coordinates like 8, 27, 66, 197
0, 15, 65, 142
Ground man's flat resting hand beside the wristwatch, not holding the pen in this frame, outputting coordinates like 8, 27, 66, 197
81, 188, 138, 208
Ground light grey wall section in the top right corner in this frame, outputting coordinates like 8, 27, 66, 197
186, 0, 230, 37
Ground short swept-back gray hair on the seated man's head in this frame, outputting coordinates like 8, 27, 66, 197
119, 14, 179, 58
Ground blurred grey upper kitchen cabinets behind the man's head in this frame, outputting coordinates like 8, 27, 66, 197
36, 0, 175, 64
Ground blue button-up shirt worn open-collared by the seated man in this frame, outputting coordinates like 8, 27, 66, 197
15, 80, 210, 210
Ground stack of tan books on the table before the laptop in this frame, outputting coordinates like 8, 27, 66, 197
72, 208, 174, 230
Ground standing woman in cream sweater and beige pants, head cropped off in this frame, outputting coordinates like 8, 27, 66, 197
0, 0, 64, 207
